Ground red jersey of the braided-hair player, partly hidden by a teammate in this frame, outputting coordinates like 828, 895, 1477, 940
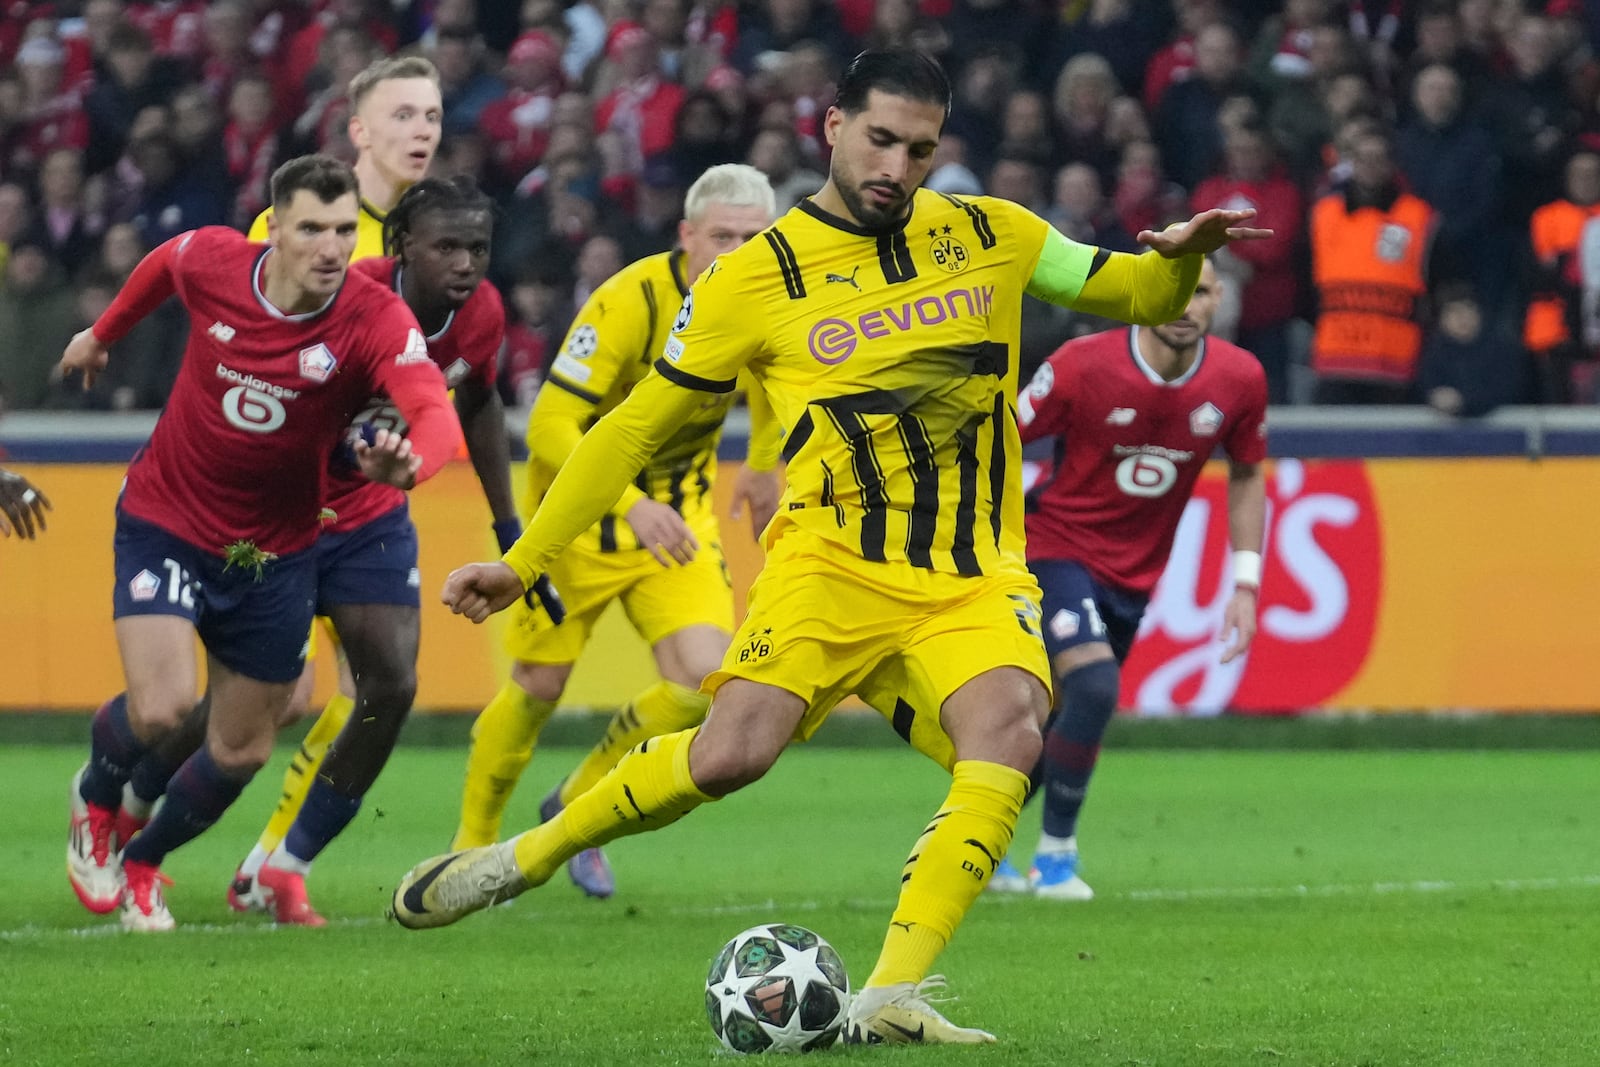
323, 256, 506, 533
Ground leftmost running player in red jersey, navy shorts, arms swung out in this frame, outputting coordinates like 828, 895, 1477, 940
61, 155, 461, 931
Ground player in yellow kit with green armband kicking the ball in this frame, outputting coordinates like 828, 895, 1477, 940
394, 51, 1266, 1043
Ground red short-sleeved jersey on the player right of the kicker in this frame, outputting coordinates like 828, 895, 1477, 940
1018, 326, 1267, 595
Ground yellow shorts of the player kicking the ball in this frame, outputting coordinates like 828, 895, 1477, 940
701, 526, 1051, 769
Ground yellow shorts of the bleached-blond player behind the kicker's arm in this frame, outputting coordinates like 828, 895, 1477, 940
506, 530, 733, 664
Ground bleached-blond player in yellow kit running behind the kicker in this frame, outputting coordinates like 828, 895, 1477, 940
451, 163, 781, 897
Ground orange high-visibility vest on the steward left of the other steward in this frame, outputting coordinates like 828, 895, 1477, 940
1310, 192, 1434, 382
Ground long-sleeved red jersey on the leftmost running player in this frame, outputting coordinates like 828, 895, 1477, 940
104, 226, 459, 555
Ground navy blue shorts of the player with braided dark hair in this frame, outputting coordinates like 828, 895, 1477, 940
312, 504, 422, 614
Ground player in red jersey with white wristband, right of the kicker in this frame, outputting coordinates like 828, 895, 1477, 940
990, 261, 1267, 901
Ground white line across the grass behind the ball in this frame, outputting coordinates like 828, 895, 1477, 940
0, 875, 1600, 944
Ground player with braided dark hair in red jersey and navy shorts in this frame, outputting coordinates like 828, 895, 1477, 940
117, 178, 522, 926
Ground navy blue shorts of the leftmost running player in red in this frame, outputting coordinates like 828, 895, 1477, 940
112, 510, 317, 681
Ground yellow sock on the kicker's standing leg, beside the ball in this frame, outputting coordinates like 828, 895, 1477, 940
866, 760, 1027, 985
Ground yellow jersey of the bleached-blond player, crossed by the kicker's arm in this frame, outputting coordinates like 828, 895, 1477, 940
528, 251, 733, 552
